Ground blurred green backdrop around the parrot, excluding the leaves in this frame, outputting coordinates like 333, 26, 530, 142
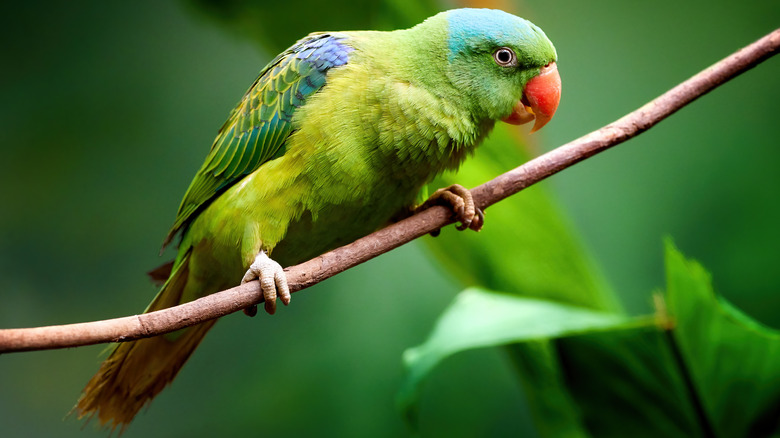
0, 0, 780, 437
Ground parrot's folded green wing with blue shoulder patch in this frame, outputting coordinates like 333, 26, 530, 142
163, 33, 353, 248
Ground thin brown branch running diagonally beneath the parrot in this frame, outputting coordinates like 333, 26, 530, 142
0, 29, 780, 353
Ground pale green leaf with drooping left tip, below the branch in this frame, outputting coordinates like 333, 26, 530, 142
399, 288, 631, 420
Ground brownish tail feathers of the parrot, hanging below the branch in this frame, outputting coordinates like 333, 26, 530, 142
71, 253, 216, 434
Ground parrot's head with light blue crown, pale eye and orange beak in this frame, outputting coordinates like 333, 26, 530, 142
442, 9, 561, 132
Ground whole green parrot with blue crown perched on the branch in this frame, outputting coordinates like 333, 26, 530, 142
74, 9, 561, 430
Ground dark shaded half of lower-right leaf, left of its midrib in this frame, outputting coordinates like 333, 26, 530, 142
544, 324, 708, 438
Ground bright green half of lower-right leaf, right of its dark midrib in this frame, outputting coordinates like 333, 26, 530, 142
666, 241, 780, 437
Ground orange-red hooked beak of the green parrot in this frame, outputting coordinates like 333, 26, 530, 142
502, 62, 561, 132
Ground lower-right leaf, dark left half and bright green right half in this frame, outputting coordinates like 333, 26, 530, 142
536, 242, 780, 438
